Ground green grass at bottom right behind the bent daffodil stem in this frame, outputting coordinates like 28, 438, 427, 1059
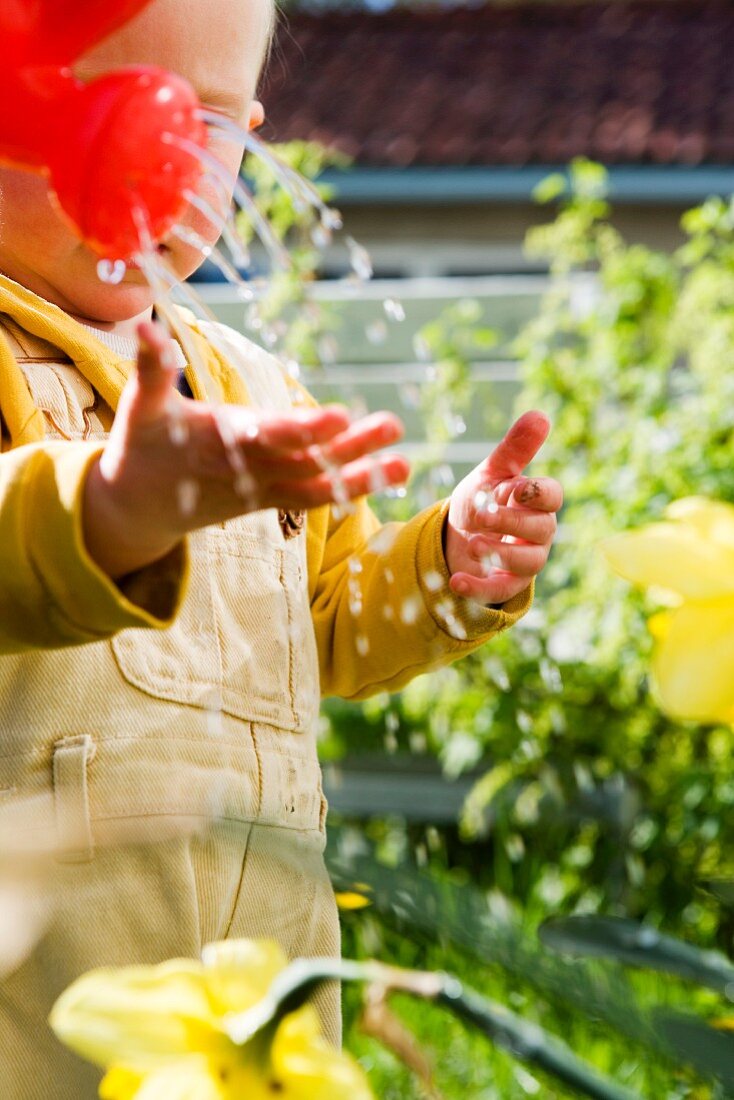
342, 911, 722, 1100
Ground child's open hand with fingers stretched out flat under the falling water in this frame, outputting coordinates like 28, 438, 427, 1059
84, 323, 408, 578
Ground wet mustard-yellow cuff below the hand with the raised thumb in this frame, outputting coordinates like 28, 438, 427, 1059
416, 501, 535, 644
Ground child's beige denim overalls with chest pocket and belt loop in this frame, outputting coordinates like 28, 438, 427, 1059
0, 314, 339, 1100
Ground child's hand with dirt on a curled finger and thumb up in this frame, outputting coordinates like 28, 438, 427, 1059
445, 413, 563, 604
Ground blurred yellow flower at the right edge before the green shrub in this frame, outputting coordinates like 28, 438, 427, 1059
602, 497, 734, 723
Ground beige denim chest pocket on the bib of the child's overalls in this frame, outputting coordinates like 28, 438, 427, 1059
111, 512, 318, 732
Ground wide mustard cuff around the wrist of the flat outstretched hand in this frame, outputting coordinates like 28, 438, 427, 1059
24, 443, 188, 644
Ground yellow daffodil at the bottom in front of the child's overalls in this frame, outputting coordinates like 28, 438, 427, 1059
51, 939, 372, 1100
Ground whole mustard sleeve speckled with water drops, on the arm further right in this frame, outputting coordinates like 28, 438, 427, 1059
308, 499, 533, 699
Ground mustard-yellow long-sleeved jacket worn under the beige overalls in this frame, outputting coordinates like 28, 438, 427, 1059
0, 277, 532, 699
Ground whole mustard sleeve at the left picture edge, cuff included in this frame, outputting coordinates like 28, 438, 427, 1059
0, 441, 188, 653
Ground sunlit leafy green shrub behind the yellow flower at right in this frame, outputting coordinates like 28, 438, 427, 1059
326, 162, 734, 947
